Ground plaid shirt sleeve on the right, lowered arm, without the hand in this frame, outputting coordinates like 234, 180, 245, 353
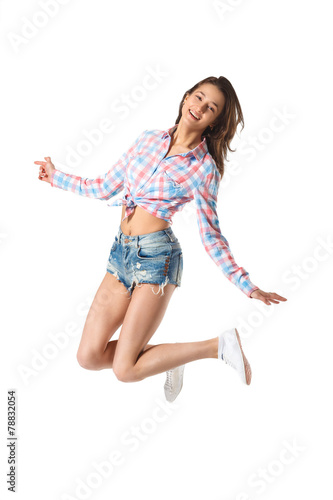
194, 164, 259, 297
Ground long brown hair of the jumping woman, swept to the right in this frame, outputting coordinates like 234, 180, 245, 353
175, 76, 244, 179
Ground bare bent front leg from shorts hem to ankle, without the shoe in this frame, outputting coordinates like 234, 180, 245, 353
113, 283, 218, 382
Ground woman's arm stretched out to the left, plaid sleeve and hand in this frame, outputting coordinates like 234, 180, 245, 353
35, 131, 146, 200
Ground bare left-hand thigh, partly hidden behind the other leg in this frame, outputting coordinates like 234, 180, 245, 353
77, 272, 131, 360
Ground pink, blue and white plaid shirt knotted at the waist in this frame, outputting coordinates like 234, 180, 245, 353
51, 125, 259, 296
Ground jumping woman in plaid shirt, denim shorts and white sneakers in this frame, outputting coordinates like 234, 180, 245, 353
34, 76, 287, 401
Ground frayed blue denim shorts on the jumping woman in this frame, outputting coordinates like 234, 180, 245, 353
106, 226, 183, 296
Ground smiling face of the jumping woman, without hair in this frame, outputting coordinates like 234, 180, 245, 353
182, 83, 225, 132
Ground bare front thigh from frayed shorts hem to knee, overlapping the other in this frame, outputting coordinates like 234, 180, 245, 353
113, 283, 176, 379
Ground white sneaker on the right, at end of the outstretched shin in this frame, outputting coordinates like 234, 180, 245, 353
218, 328, 252, 385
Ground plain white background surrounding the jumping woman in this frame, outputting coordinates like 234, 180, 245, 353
0, 0, 333, 500
